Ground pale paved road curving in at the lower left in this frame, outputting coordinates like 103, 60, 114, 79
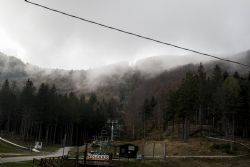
0, 147, 71, 164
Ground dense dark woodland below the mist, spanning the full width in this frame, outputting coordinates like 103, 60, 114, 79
0, 64, 250, 145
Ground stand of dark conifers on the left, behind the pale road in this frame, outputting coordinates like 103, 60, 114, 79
0, 80, 115, 145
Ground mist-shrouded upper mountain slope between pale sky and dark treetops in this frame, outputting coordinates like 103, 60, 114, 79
0, 51, 250, 98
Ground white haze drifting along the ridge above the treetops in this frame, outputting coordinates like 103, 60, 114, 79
0, 51, 250, 94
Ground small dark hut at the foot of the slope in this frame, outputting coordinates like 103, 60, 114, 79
119, 144, 139, 158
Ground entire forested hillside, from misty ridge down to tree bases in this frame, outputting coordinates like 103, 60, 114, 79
0, 52, 250, 144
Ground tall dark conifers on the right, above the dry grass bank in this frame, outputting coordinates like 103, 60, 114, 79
140, 64, 250, 140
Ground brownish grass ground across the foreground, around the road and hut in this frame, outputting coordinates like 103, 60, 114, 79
0, 137, 250, 167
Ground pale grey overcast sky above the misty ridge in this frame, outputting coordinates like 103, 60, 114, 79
0, 0, 250, 69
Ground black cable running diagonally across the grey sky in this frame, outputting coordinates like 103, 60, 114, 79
24, 0, 250, 68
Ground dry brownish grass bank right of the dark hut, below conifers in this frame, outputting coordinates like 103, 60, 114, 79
115, 137, 248, 156
